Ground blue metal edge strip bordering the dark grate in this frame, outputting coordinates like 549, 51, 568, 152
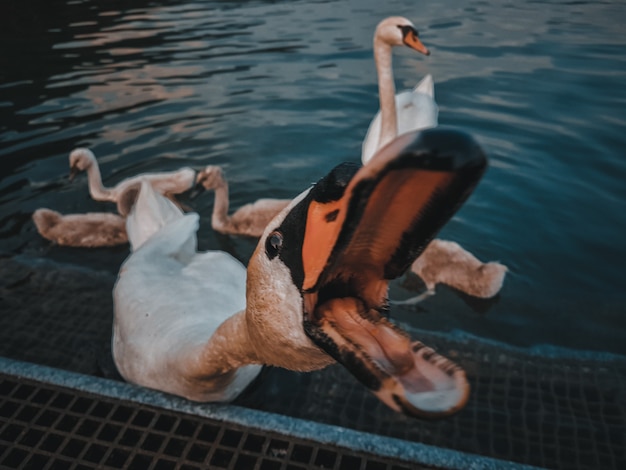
0, 357, 536, 470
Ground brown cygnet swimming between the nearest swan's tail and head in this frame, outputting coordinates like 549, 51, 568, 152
196, 165, 291, 238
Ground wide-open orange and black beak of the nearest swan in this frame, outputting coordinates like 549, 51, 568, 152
301, 128, 487, 417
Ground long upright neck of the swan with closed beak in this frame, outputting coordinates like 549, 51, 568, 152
374, 37, 398, 148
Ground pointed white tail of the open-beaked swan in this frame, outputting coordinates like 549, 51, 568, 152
122, 179, 183, 251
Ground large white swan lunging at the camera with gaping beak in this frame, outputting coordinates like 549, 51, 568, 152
112, 129, 486, 416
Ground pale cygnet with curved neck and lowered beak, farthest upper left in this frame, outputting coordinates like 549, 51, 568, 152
69, 148, 196, 203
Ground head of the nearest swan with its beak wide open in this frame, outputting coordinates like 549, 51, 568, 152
247, 129, 486, 416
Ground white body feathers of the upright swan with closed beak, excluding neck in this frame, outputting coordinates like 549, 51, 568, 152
361, 74, 439, 165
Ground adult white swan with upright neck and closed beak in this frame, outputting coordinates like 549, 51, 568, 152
361, 16, 439, 164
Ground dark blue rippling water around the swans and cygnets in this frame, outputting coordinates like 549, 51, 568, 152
0, 0, 626, 354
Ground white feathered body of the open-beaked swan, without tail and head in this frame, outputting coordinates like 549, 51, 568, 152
113, 205, 260, 401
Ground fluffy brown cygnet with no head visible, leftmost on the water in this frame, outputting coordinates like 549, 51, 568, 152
32, 208, 128, 248
